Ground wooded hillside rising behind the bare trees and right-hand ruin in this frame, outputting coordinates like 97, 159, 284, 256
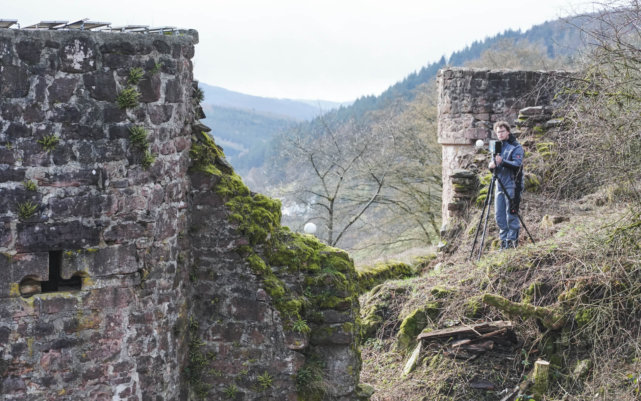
265, 13, 582, 262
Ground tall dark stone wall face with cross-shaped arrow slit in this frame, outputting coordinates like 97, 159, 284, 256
0, 26, 196, 401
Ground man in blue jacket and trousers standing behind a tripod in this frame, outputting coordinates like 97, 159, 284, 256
489, 121, 524, 249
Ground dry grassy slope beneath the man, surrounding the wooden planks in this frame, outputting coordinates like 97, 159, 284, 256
361, 133, 641, 401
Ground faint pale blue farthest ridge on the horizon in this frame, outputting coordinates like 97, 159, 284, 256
199, 82, 350, 121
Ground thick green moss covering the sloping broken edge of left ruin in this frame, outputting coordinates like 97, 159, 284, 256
190, 133, 360, 400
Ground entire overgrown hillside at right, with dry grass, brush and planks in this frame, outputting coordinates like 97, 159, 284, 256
361, 2, 641, 401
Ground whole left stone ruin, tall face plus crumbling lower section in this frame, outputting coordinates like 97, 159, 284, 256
0, 29, 360, 401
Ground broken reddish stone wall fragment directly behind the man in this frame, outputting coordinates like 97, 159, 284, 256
437, 68, 567, 229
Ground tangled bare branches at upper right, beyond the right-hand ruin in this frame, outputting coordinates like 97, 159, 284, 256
548, 0, 641, 200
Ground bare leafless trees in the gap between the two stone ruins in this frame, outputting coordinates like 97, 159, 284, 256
278, 86, 441, 250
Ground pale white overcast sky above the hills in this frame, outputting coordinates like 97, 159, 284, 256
0, 0, 586, 101
